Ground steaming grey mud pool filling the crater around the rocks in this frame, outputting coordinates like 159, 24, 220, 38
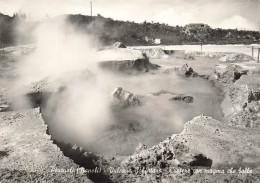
41, 59, 222, 155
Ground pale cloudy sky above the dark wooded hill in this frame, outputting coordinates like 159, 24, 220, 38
0, 0, 260, 30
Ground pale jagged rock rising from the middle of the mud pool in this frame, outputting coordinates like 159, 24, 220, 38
112, 87, 141, 109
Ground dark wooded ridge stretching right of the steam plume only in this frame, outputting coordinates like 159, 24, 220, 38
68, 15, 260, 45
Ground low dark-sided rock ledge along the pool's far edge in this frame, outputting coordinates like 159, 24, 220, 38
99, 58, 160, 74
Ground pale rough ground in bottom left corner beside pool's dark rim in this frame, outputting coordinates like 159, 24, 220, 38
0, 109, 90, 182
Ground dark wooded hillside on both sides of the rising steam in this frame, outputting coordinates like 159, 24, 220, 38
0, 14, 260, 45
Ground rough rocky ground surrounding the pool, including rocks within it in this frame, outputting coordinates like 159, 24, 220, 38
0, 45, 260, 183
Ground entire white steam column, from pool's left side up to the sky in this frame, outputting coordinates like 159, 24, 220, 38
15, 17, 116, 149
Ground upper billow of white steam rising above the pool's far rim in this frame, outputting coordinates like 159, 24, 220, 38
19, 16, 98, 82
